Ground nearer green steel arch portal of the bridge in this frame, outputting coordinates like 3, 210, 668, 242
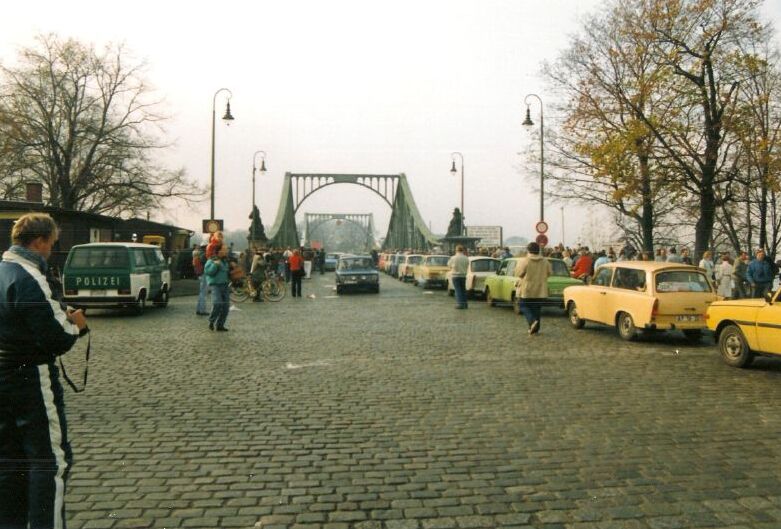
268, 173, 439, 250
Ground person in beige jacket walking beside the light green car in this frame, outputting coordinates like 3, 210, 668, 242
515, 242, 553, 336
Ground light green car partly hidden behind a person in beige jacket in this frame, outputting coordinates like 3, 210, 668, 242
483, 257, 583, 313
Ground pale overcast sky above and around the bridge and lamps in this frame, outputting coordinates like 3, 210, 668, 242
0, 0, 781, 244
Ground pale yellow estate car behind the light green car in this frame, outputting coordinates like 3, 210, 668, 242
564, 261, 719, 341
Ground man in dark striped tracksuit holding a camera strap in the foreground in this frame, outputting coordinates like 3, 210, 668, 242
0, 213, 88, 529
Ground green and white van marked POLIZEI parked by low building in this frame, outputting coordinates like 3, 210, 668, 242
62, 242, 171, 313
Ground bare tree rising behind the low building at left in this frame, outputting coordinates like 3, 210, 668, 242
0, 35, 203, 215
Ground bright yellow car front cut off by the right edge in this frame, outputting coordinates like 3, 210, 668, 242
705, 289, 781, 367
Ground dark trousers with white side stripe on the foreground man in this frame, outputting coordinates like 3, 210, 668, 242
0, 363, 73, 529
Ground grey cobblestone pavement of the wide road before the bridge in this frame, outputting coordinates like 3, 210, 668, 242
66, 274, 781, 529
